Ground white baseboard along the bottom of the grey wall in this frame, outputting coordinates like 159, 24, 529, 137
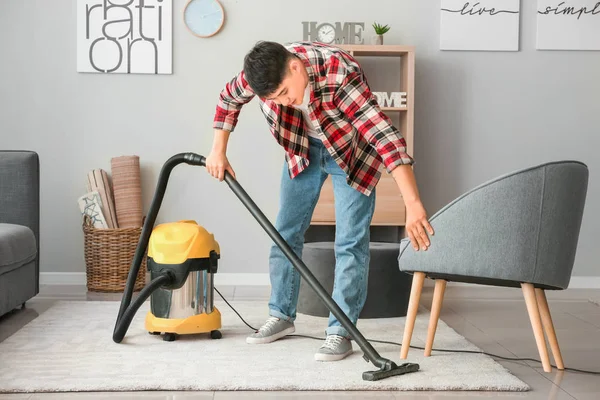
40, 272, 600, 289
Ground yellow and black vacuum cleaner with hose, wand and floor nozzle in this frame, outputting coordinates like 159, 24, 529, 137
113, 153, 419, 381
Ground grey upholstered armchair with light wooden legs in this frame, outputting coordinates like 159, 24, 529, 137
398, 161, 589, 372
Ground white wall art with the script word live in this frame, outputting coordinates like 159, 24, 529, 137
440, 0, 521, 51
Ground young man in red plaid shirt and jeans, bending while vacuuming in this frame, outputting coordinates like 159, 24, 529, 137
206, 42, 433, 361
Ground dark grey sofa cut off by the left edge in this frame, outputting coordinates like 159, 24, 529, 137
0, 151, 40, 316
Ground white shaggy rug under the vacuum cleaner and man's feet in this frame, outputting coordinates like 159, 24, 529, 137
0, 301, 529, 392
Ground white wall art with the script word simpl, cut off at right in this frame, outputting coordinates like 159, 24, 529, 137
537, 0, 600, 50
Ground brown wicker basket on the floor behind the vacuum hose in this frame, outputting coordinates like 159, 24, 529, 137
83, 216, 147, 292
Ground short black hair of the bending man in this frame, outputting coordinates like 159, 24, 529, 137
244, 41, 294, 98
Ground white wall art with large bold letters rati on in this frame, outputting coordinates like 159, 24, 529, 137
77, 0, 173, 74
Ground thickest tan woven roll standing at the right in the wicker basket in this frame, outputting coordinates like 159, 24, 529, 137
110, 156, 143, 228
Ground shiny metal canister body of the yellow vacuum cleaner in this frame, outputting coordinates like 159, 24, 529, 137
150, 270, 214, 319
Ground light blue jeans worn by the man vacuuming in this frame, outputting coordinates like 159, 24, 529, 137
269, 138, 375, 338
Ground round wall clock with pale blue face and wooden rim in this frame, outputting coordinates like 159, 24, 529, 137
183, 0, 225, 38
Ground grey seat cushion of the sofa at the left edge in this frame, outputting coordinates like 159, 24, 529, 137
0, 223, 37, 275
